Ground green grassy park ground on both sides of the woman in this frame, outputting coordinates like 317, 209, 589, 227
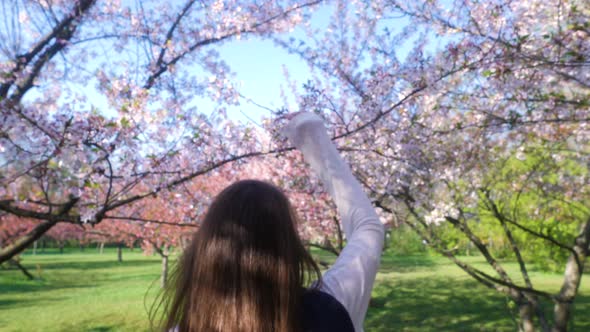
0, 248, 590, 332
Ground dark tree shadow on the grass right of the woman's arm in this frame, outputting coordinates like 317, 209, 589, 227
365, 276, 590, 332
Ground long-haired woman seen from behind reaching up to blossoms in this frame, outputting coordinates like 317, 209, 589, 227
157, 113, 383, 332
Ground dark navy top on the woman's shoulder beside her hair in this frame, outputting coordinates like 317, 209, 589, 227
303, 290, 354, 332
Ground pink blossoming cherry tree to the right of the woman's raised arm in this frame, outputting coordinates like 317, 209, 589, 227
277, 0, 590, 331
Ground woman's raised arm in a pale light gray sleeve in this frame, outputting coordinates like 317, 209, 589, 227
284, 113, 384, 332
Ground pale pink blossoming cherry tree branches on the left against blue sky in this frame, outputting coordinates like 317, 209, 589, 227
0, 0, 318, 262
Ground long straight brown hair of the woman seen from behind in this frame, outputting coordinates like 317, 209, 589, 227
155, 180, 321, 332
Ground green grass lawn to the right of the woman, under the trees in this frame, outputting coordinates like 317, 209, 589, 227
365, 256, 590, 331
